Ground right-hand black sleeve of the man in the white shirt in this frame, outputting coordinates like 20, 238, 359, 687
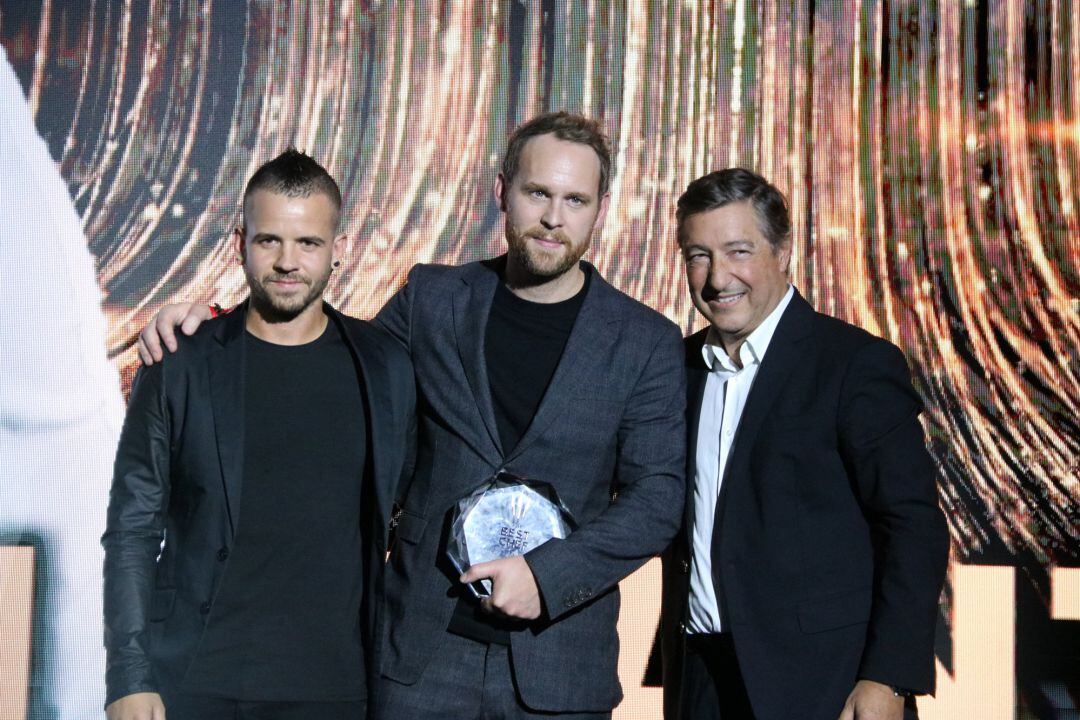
838, 341, 949, 693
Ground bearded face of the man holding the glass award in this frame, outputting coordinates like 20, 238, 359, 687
495, 135, 608, 280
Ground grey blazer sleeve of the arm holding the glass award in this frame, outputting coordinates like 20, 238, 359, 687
525, 324, 686, 620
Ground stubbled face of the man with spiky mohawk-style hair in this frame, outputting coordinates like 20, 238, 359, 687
235, 190, 346, 322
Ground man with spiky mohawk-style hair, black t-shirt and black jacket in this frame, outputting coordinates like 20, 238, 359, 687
103, 150, 415, 720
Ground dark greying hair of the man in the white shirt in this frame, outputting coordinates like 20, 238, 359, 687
675, 167, 792, 253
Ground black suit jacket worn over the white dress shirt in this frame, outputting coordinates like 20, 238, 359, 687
663, 293, 948, 720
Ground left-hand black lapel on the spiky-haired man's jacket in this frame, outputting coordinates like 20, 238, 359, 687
206, 302, 247, 535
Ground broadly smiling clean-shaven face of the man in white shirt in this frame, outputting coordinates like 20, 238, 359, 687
679, 202, 791, 357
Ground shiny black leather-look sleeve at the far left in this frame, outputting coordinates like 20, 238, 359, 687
102, 358, 170, 705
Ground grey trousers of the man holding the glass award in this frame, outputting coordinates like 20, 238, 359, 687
375, 633, 611, 720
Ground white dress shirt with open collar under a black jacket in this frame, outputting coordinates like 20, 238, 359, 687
686, 285, 795, 633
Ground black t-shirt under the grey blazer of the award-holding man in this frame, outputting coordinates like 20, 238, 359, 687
448, 267, 592, 644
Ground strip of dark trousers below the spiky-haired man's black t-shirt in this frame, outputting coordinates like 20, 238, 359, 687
162, 693, 367, 720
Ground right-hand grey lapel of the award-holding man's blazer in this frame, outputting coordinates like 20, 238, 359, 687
507, 266, 619, 462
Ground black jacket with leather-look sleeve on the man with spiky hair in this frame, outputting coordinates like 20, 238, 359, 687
102, 303, 416, 703
